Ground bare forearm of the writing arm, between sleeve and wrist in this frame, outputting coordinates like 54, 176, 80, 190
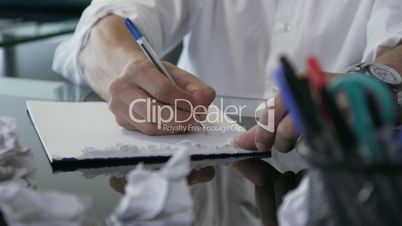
79, 15, 144, 100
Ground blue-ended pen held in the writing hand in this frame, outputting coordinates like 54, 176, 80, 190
124, 18, 177, 86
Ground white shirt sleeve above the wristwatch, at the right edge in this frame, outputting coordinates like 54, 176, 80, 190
363, 0, 402, 63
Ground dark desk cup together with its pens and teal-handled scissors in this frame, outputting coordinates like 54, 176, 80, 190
275, 57, 402, 226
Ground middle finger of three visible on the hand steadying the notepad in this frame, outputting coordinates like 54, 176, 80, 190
255, 95, 287, 151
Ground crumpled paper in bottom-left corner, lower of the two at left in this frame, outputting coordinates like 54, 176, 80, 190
0, 182, 90, 226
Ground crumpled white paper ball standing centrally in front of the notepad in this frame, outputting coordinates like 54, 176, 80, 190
108, 147, 194, 226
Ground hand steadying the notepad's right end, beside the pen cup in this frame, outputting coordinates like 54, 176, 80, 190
234, 72, 336, 152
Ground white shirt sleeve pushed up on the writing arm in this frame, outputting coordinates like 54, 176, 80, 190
53, 0, 203, 84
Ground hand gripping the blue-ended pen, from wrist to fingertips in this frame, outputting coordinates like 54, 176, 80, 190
109, 57, 215, 135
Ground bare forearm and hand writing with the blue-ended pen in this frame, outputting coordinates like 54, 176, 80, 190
79, 15, 215, 135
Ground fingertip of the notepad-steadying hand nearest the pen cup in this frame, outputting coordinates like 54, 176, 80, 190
274, 114, 299, 152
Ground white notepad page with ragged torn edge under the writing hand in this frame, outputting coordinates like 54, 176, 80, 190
27, 101, 261, 162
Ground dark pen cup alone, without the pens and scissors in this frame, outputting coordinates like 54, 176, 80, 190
308, 164, 402, 226
